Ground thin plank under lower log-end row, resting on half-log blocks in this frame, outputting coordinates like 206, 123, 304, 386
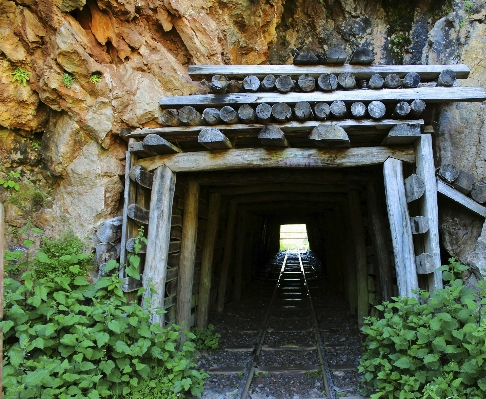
126, 119, 424, 140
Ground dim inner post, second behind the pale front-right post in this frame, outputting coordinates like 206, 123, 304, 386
348, 190, 369, 327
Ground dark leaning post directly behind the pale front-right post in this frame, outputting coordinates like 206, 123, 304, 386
366, 181, 393, 301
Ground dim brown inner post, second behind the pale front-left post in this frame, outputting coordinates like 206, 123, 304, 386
196, 193, 221, 328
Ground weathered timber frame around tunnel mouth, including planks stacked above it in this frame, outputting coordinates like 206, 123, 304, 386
120, 65, 486, 327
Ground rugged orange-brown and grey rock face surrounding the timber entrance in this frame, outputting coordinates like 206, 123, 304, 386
0, 0, 486, 276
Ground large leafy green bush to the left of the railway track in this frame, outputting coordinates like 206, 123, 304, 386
1, 236, 206, 399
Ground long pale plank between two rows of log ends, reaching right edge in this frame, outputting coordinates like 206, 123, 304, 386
159, 86, 486, 108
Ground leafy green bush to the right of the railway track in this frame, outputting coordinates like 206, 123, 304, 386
359, 259, 486, 399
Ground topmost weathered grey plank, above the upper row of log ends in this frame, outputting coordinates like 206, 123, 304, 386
189, 64, 470, 80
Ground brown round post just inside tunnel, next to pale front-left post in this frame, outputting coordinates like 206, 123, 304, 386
176, 180, 199, 328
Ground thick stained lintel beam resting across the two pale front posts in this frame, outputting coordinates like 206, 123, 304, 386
138, 147, 415, 172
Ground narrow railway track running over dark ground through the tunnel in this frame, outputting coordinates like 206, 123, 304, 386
209, 251, 359, 399
